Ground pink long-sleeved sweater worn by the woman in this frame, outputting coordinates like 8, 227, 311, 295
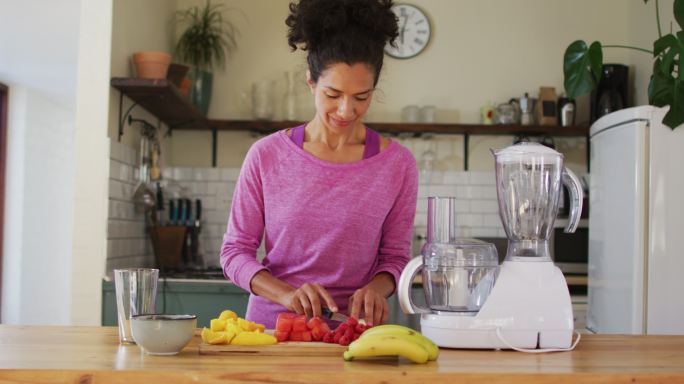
221, 130, 418, 328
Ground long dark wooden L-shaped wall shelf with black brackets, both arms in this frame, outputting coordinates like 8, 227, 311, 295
111, 77, 589, 171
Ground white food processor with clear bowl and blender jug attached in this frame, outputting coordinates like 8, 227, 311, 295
397, 142, 583, 352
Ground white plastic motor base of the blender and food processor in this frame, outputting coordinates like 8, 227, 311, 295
420, 259, 574, 349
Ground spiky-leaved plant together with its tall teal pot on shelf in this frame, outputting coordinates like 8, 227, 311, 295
174, 0, 238, 115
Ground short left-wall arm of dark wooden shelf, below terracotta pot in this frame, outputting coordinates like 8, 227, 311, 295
110, 77, 210, 138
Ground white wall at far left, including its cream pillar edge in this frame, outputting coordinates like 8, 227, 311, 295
0, 0, 111, 324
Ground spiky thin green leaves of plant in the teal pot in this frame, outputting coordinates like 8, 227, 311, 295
175, 0, 239, 71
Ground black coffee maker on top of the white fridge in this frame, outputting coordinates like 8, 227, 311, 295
591, 64, 629, 122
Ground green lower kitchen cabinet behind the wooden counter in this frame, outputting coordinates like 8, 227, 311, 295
102, 279, 425, 330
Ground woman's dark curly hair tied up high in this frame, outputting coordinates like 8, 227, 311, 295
285, 0, 398, 85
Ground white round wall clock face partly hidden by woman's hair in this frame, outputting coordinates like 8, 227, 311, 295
385, 4, 430, 59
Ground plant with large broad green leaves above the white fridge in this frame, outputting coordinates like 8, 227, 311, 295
563, 0, 684, 129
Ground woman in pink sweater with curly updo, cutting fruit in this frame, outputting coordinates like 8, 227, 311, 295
221, 0, 417, 328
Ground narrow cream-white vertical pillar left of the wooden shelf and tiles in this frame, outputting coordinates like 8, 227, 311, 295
70, 0, 112, 325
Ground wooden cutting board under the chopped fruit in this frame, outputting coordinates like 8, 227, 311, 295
199, 341, 347, 357
